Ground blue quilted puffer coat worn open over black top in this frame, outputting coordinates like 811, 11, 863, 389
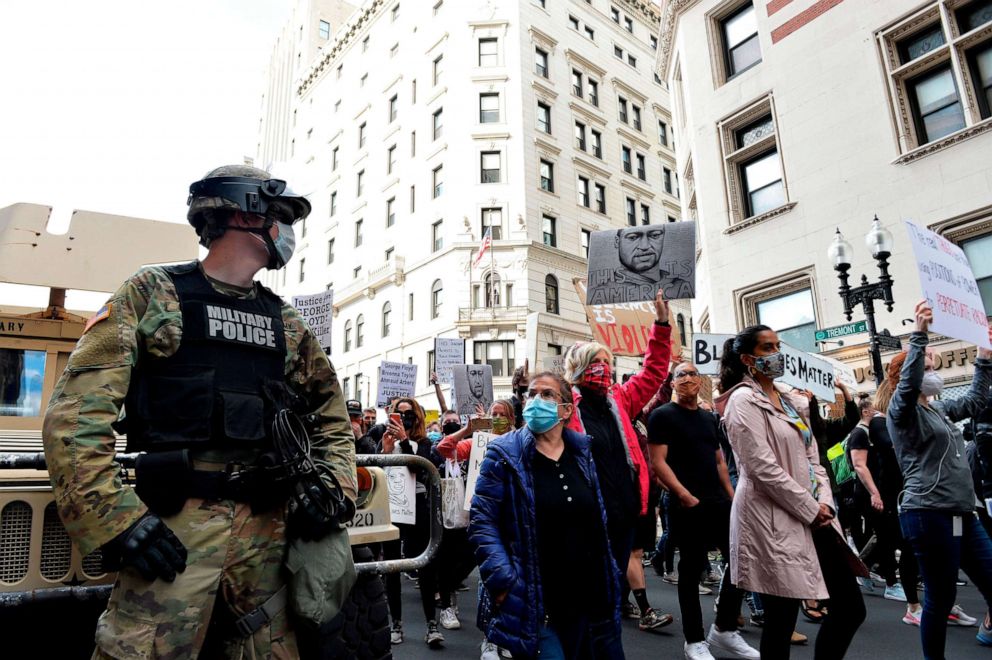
468, 426, 620, 657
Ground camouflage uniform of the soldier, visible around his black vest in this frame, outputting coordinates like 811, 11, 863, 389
44, 260, 357, 658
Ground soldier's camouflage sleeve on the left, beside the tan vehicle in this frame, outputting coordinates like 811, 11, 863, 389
42, 269, 171, 555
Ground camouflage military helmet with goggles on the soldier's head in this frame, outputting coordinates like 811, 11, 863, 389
186, 165, 310, 234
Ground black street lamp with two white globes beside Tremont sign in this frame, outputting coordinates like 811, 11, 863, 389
827, 215, 895, 387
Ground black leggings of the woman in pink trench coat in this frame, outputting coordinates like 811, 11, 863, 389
760, 527, 866, 660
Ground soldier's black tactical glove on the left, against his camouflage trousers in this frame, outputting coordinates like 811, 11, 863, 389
103, 513, 186, 582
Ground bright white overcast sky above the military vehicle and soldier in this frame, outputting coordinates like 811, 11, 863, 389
0, 0, 290, 227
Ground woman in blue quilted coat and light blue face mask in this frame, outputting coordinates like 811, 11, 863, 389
469, 372, 624, 660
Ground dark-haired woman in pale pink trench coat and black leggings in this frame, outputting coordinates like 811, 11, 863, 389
716, 326, 865, 660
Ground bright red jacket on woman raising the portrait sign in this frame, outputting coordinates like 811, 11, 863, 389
568, 323, 672, 516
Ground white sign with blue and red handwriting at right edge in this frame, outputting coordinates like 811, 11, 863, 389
906, 220, 992, 348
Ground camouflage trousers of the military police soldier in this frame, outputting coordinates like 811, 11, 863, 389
93, 498, 299, 659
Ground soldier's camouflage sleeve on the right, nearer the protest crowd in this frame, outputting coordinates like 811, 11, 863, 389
283, 305, 358, 501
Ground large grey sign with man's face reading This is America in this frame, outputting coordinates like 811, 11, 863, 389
586, 222, 696, 305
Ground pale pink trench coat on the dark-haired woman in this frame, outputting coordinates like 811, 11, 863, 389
715, 377, 840, 599
